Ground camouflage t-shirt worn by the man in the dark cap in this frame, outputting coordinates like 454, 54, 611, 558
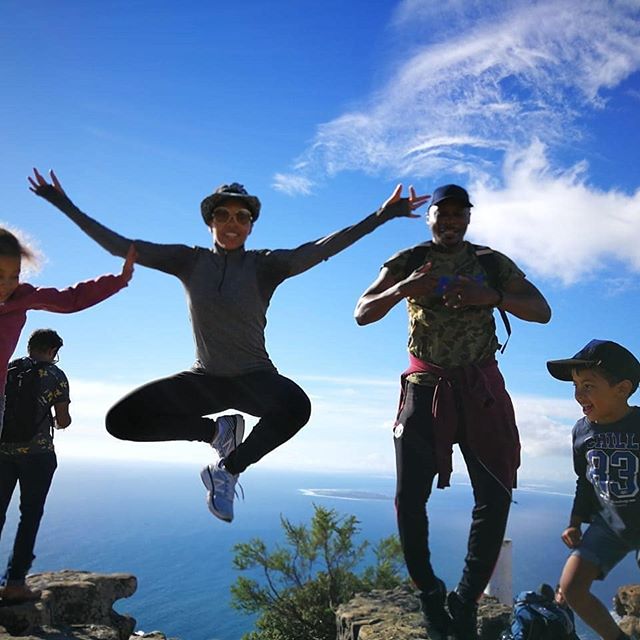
383, 242, 524, 385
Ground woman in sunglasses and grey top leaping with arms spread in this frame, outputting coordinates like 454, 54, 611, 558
31, 171, 429, 522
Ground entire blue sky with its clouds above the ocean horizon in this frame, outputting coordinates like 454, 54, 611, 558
0, 0, 640, 483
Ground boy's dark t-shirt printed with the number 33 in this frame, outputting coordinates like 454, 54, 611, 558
572, 407, 640, 547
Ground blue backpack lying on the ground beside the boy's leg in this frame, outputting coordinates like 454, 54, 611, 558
500, 587, 579, 640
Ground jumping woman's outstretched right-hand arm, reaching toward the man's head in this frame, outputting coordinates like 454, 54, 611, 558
271, 184, 431, 277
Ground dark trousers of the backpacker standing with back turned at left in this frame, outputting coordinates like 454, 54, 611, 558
0, 451, 58, 584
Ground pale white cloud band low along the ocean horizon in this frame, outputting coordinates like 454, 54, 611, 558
55, 376, 579, 481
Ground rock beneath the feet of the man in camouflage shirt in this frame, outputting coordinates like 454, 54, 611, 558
336, 587, 511, 640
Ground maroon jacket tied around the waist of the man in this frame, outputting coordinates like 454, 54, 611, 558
396, 354, 520, 493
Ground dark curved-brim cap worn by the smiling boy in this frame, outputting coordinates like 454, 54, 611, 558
547, 340, 640, 395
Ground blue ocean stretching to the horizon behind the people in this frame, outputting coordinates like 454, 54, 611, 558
0, 459, 640, 640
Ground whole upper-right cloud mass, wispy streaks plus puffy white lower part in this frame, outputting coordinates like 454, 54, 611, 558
279, 0, 640, 283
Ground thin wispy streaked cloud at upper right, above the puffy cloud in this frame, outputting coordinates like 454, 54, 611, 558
280, 0, 640, 182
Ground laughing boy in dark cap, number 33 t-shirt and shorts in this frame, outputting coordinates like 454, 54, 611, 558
547, 340, 640, 640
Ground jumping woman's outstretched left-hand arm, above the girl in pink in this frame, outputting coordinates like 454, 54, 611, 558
27, 168, 192, 275
